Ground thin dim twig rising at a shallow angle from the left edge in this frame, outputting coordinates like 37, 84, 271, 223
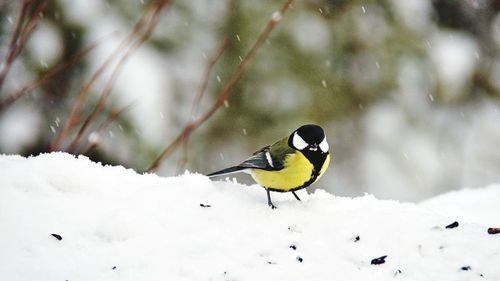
0, 34, 113, 113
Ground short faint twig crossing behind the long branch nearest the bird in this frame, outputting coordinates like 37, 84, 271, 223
177, 37, 229, 172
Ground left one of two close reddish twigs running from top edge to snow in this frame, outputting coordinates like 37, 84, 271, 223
50, 0, 171, 151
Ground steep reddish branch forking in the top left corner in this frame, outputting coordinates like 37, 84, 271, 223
0, 0, 49, 91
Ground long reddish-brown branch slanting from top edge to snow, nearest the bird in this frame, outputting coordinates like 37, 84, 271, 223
147, 0, 293, 172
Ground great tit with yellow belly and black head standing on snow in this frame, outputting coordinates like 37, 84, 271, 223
207, 124, 330, 209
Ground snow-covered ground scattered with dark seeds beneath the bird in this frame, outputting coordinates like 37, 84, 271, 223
0, 153, 500, 281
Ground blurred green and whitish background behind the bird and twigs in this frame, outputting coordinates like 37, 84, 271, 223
0, 0, 500, 201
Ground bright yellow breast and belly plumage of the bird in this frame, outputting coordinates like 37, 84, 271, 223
252, 152, 330, 191
